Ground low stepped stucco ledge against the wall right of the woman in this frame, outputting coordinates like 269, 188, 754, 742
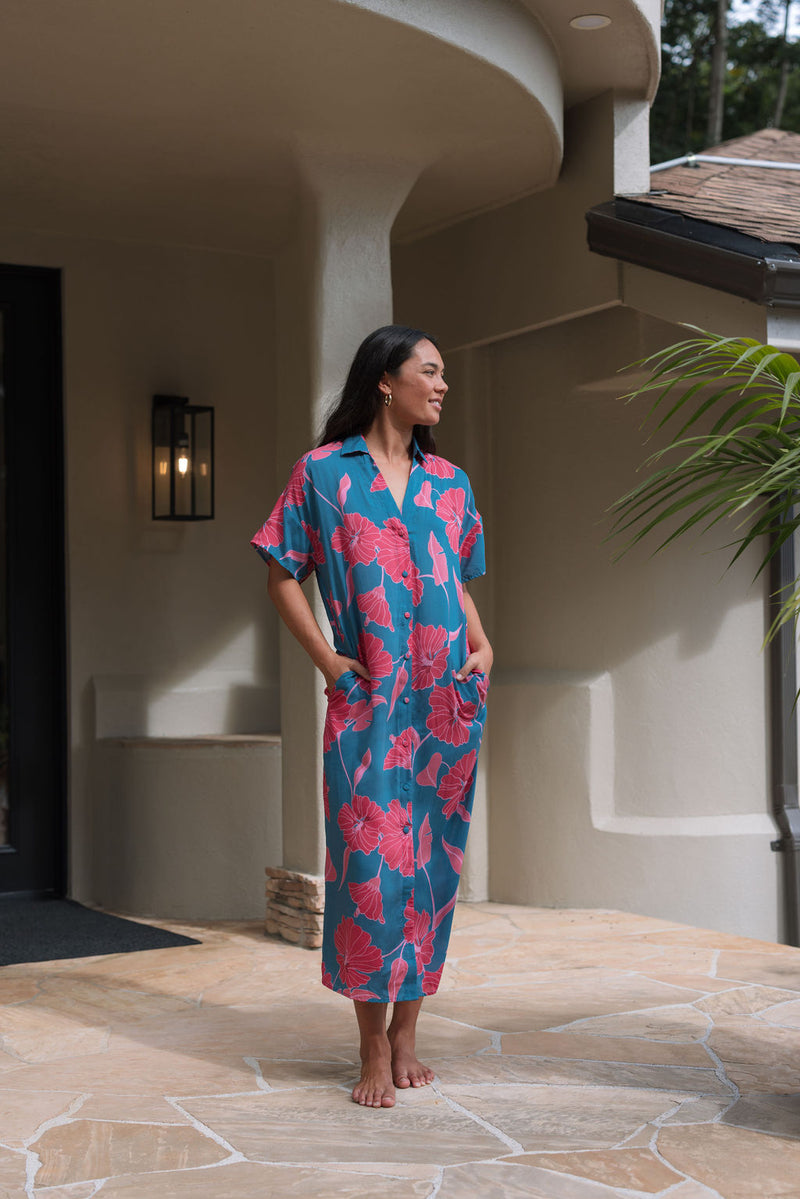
489, 671, 780, 940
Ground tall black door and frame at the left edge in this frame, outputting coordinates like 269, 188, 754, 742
0, 265, 67, 897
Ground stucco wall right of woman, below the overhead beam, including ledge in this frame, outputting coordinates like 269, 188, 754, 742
488, 309, 778, 939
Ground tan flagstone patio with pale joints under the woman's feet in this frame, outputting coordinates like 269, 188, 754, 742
0, 904, 800, 1199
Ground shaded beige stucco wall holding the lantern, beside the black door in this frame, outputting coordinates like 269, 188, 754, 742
0, 230, 281, 915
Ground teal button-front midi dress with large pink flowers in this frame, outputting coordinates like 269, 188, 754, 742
252, 436, 488, 1002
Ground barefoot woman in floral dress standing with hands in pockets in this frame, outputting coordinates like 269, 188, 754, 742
252, 325, 492, 1107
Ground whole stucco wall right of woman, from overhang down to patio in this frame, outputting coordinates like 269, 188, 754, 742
395, 94, 780, 938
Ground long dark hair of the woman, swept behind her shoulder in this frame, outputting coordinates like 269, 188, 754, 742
317, 325, 439, 453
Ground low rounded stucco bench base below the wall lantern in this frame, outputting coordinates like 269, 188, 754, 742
92, 735, 282, 920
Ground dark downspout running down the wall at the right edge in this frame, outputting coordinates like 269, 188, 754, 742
770, 522, 800, 946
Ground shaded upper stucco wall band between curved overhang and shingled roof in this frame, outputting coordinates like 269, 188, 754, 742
392, 92, 623, 350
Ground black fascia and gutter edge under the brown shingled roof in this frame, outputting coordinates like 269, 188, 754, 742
587, 198, 800, 308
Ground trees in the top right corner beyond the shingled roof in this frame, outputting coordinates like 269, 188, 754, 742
650, 0, 800, 162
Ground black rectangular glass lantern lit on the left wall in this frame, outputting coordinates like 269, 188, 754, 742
152, 396, 213, 520
